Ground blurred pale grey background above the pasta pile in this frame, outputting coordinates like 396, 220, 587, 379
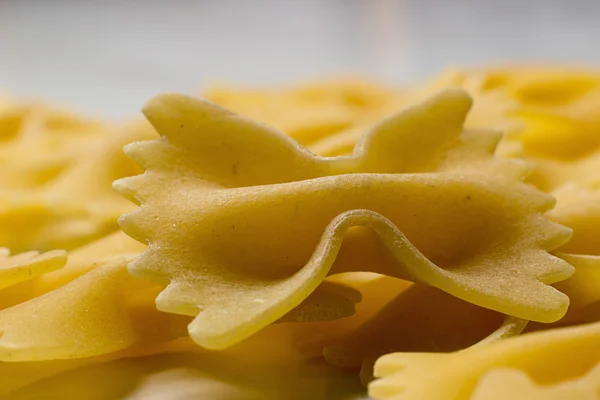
0, 0, 600, 118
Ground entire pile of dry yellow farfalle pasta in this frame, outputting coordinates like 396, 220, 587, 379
0, 67, 600, 400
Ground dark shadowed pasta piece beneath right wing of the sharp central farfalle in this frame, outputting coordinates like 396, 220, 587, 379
308, 284, 527, 381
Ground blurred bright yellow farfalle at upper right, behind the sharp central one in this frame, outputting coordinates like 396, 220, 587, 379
430, 67, 600, 191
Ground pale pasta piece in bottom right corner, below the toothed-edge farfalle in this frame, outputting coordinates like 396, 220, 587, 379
469, 364, 600, 400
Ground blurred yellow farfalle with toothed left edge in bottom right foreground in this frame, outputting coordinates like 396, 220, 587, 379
369, 323, 600, 400
